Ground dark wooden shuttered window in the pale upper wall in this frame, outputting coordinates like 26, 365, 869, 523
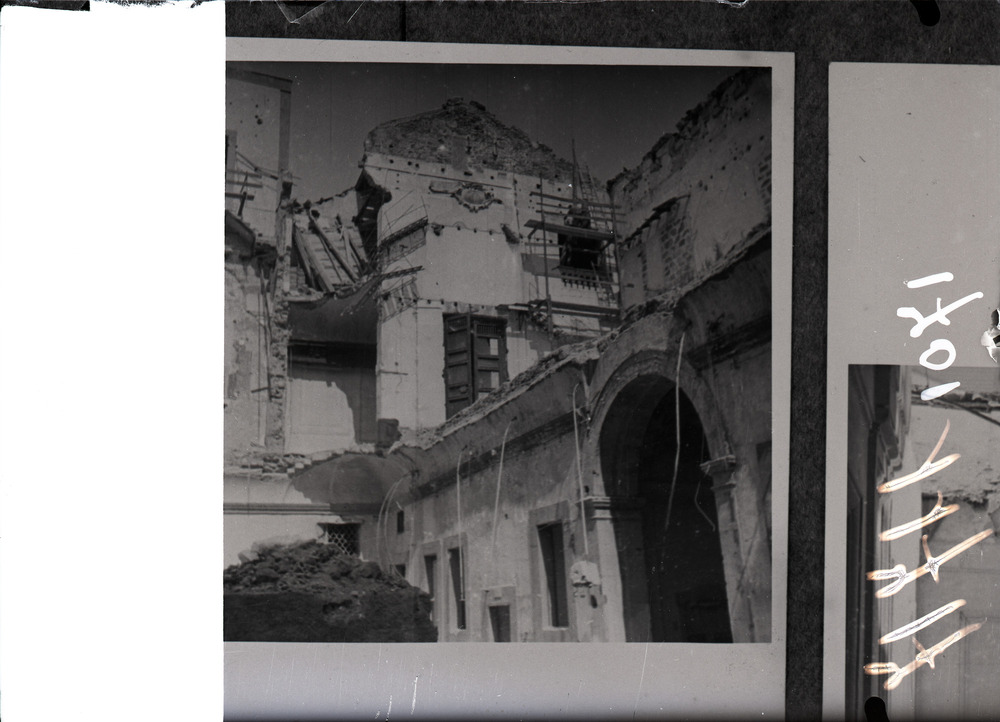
444, 313, 507, 417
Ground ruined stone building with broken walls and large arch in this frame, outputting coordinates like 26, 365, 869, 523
225, 69, 771, 642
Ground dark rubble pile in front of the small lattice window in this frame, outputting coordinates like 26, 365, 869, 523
223, 541, 437, 642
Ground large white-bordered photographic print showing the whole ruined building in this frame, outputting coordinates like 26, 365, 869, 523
223, 41, 791, 710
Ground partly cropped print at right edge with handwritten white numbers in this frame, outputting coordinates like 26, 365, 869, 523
824, 64, 1000, 720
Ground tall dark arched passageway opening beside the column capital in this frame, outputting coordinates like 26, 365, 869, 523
600, 375, 733, 642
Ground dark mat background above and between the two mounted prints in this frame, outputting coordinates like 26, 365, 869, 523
226, 0, 1000, 720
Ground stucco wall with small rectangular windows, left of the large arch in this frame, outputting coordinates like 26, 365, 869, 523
389, 427, 588, 642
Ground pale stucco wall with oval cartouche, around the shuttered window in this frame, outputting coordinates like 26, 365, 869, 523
364, 152, 617, 429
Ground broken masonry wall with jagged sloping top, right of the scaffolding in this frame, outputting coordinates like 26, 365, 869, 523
609, 68, 771, 309
